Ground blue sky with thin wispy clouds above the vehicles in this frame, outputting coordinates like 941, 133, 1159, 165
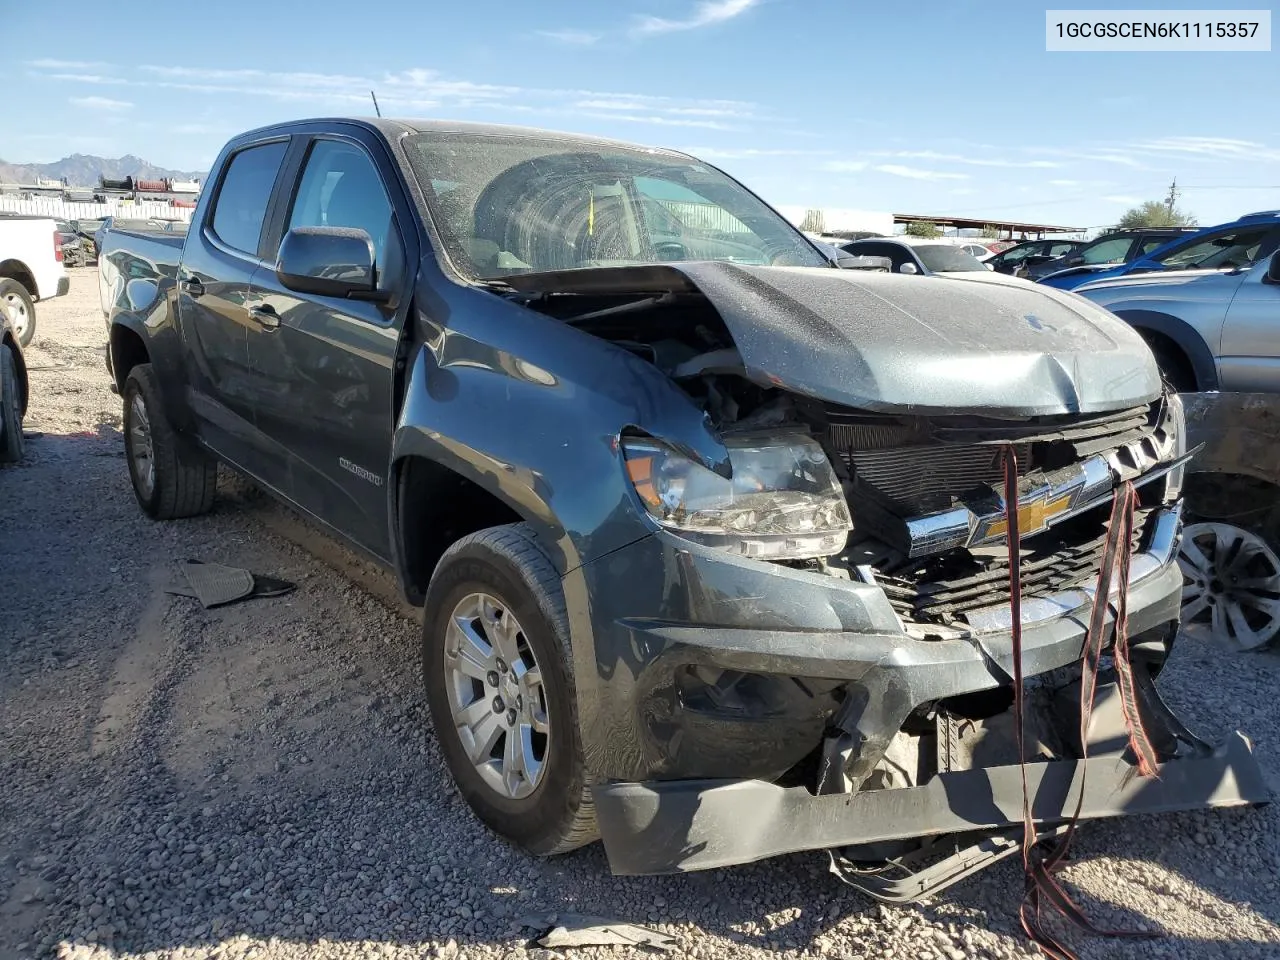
10, 0, 1280, 227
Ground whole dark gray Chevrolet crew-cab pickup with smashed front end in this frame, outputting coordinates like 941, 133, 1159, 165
100, 120, 1266, 899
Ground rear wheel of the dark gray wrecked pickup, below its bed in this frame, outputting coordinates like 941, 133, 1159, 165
124, 364, 218, 520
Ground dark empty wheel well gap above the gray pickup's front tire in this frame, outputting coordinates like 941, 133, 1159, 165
396, 457, 524, 604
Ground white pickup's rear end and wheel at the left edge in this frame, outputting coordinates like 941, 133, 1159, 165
0, 215, 70, 347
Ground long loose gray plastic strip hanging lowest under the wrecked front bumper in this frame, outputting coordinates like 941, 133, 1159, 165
594, 733, 1271, 876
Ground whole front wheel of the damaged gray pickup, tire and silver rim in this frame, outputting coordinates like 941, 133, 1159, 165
422, 524, 596, 856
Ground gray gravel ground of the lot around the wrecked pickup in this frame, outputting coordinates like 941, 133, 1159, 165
0, 270, 1280, 960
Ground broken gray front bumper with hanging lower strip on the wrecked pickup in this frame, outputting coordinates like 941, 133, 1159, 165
576, 504, 1270, 899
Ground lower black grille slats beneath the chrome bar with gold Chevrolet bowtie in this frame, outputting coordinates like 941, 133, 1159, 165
877, 502, 1152, 623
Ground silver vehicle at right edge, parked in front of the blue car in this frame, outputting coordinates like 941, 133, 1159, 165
1075, 238, 1280, 393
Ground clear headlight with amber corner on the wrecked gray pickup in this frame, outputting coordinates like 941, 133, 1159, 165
622, 434, 854, 559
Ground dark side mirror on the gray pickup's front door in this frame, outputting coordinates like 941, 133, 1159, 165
275, 227, 389, 301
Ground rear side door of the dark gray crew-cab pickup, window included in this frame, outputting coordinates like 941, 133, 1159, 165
178, 140, 288, 468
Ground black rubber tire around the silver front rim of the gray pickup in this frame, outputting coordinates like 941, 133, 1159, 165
422, 524, 599, 856
